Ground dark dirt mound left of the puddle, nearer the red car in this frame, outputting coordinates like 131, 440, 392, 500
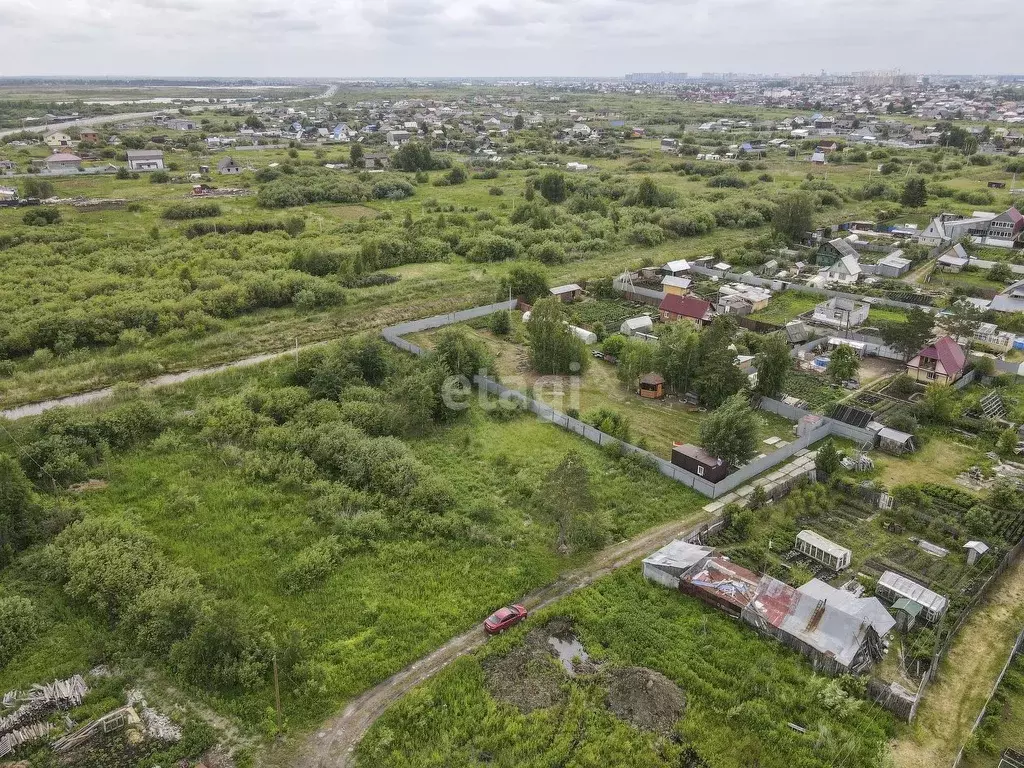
483, 628, 566, 714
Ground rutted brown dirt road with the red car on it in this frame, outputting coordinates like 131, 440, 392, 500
276, 512, 705, 768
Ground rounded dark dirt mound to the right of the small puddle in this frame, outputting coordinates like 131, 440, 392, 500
607, 667, 686, 734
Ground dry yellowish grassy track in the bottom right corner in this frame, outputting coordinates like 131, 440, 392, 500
892, 560, 1024, 768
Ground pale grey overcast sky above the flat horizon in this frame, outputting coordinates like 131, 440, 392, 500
0, 0, 1024, 78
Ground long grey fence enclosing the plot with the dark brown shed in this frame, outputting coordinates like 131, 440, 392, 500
381, 300, 847, 499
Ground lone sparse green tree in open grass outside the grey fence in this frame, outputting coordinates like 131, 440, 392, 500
536, 451, 608, 554
